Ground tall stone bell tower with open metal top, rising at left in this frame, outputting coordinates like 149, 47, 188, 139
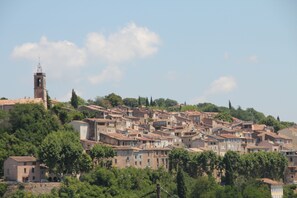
34, 62, 47, 108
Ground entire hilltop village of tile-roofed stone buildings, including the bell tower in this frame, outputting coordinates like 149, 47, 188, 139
0, 65, 297, 197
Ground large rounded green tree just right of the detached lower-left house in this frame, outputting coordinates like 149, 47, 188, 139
39, 131, 83, 176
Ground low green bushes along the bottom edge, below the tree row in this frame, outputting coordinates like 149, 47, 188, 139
4, 167, 297, 198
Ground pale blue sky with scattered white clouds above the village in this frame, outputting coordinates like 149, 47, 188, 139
0, 0, 297, 122
